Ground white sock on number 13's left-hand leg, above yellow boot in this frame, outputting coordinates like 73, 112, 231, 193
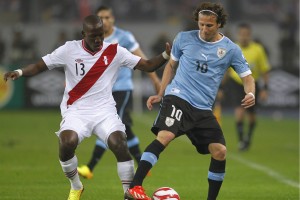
60, 155, 83, 190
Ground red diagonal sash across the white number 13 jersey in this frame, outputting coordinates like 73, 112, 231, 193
67, 44, 118, 105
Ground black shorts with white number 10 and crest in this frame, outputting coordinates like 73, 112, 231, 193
151, 95, 225, 154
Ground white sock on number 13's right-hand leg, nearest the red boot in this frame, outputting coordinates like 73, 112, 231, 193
117, 160, 134, 192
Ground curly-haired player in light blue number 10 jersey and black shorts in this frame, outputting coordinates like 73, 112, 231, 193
125, 3, 255, 200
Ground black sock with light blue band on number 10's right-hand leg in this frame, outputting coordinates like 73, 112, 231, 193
207, 158, 226, 200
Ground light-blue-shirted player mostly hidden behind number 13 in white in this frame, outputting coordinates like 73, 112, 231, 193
78, 6, 160, 179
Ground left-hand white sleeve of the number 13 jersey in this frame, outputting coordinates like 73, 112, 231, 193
42, 44, 67, 70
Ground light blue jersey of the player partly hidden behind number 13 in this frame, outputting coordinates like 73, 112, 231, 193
104, 27, 139, 92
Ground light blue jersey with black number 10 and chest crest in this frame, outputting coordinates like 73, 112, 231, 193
165, 30, 251, 110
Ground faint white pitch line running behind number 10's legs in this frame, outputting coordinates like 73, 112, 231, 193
138, 115, 300, 188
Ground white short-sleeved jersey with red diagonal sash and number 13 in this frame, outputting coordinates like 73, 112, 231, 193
42, 40, 141, 115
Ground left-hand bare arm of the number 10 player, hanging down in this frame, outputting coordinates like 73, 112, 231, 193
147, 58, 178, 110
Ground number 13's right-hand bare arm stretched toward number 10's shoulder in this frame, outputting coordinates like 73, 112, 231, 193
134, 43, 171, 72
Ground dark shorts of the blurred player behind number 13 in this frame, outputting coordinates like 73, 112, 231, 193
112, 90, 132, 126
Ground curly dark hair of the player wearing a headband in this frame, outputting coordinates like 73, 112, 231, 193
194, 2, 228, 28
